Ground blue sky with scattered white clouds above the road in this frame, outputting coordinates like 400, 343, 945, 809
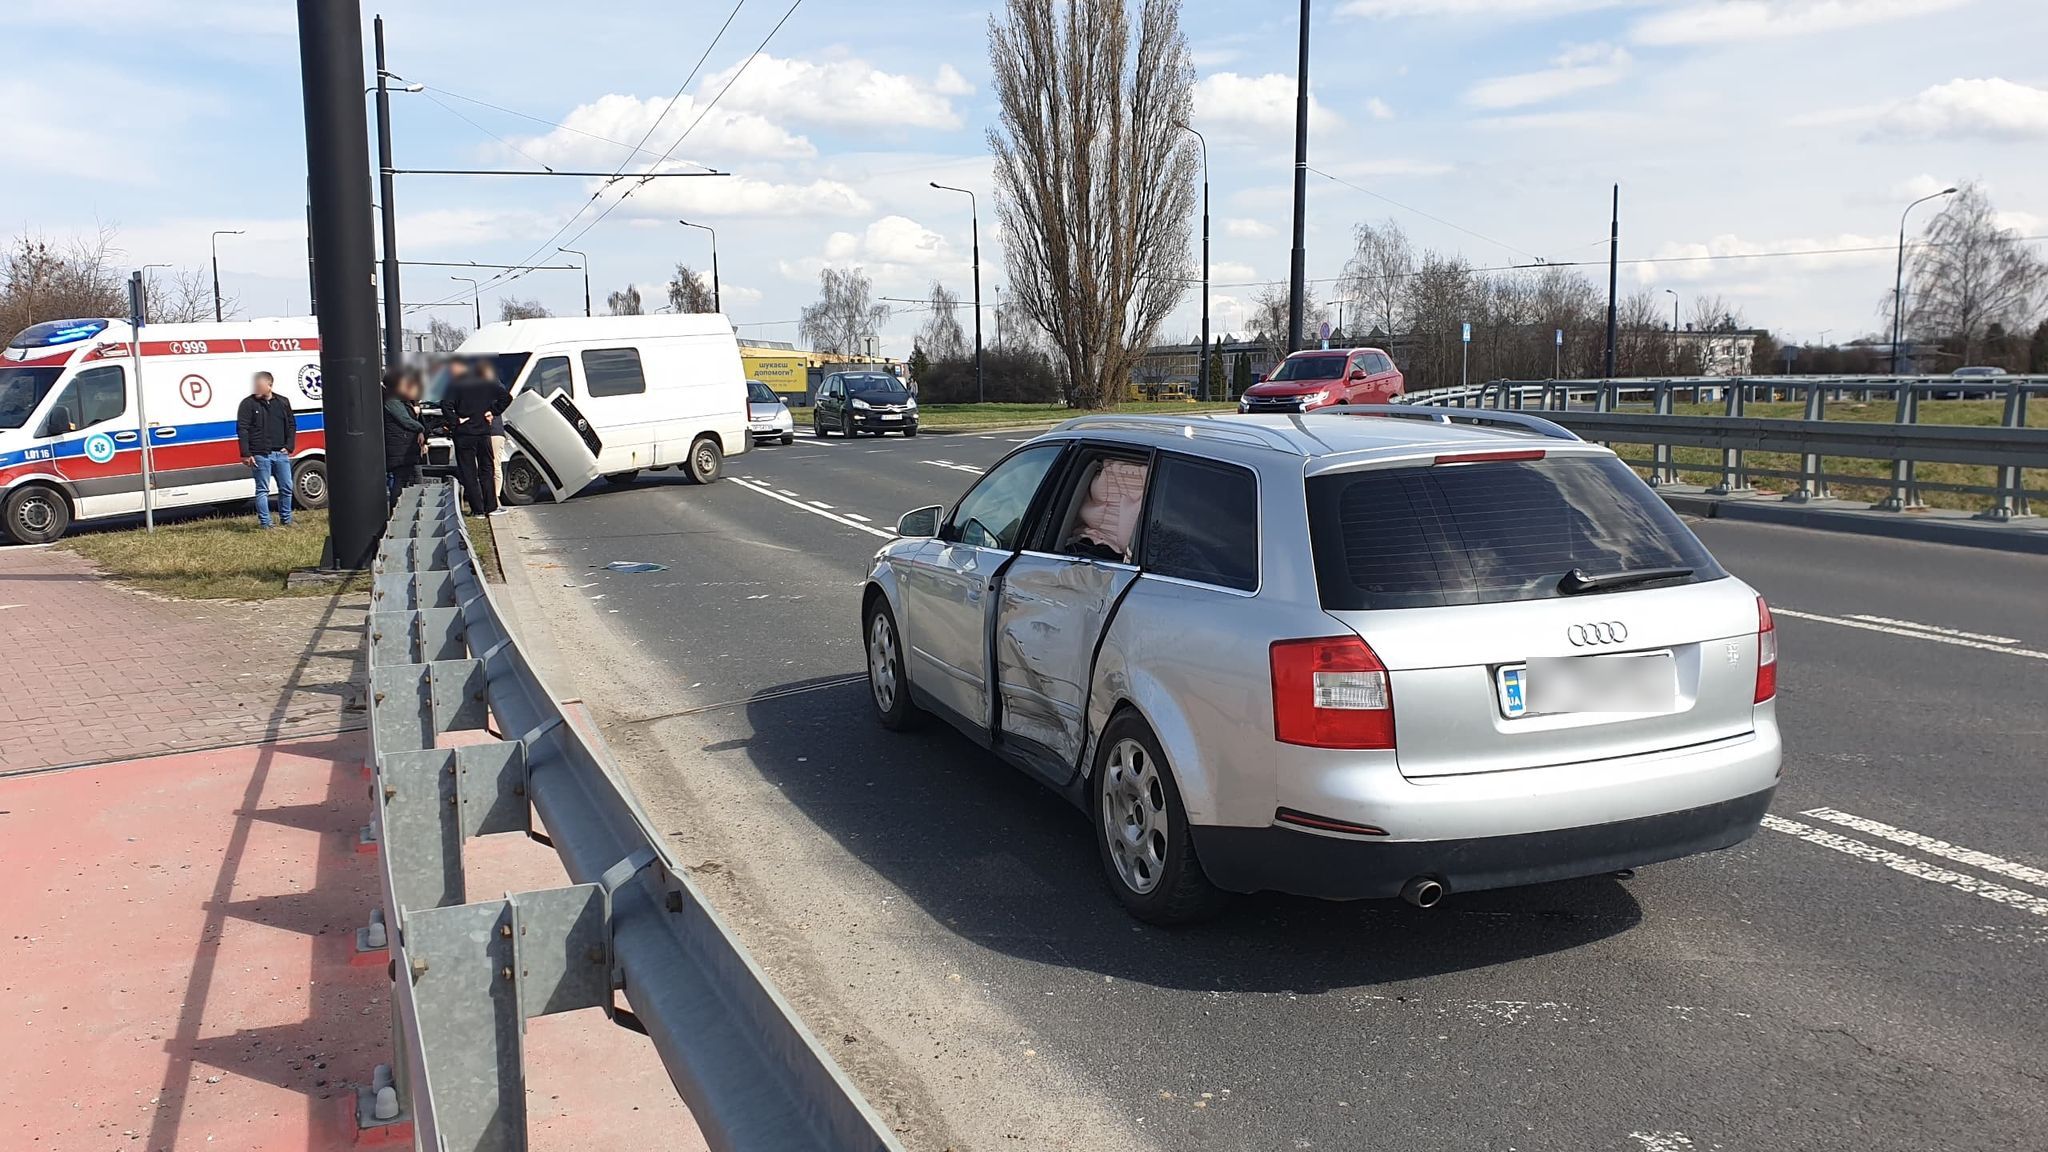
0, 0, 2048, 353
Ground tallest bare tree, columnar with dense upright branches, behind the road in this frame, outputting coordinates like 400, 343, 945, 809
989, 0, 1198, 408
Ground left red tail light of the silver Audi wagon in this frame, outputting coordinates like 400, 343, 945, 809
1272, 635, 1395, 748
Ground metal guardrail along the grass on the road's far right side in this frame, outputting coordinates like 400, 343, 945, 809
1403, 375, 2048, 521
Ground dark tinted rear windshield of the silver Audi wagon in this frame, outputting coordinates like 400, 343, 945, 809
1309, 457, 1726, 611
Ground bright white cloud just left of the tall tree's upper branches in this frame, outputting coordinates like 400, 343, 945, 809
698, 55, 975, 129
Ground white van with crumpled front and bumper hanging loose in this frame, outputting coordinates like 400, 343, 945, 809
455, 314, 748, 504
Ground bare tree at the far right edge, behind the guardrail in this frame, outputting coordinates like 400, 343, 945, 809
1907, 184, 2048, 365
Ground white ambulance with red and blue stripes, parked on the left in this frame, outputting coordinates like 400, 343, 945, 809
0, 318, 328, 543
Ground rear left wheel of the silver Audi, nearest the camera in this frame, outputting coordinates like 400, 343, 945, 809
1087, 709, 1229, 924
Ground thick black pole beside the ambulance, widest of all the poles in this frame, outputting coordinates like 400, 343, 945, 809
299, 0, 395, 570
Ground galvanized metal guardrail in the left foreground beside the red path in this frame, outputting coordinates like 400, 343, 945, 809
356, 482, 899, 1152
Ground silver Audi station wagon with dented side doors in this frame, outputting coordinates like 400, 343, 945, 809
860, 406, 1780, 922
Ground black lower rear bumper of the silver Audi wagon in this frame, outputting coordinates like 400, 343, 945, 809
1192, 787, 1778, 900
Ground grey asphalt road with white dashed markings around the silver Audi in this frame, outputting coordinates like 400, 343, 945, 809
506, 433, 2048, 1152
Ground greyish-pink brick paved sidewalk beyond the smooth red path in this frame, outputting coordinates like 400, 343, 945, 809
0, 547, 369, 775
